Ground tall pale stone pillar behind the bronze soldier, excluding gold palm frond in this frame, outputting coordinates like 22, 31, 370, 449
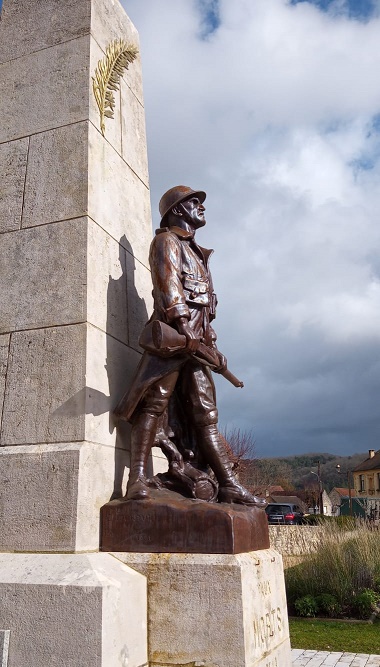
0, 0, 162, 552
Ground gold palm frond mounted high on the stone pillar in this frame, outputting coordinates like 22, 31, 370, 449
92, 39, 138, 136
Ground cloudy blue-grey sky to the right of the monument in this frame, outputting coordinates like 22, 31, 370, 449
122, 0, 380, 457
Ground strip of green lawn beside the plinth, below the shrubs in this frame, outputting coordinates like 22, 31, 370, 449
289, 618, 380, 654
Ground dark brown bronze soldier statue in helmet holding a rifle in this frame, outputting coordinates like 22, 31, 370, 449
116, 185, 265, 506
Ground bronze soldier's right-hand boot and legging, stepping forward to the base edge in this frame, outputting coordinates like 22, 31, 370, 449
198, 424, 267, 507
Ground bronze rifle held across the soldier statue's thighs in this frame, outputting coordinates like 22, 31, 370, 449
139, 320, 244, 387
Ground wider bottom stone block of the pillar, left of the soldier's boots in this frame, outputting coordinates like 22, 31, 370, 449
0, 442, 115, 552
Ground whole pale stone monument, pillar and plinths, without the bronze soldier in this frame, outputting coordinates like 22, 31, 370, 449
0, 0, 291, 667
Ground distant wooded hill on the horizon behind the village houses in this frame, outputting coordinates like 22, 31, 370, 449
239, 450, 368, 491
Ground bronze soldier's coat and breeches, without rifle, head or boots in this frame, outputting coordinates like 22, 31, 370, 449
116, 227, 217, 424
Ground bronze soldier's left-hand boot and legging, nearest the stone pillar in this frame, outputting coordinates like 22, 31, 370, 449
125, 412, 158, 500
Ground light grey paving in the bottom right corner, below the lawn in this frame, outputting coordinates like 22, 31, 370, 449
292, 648, 380, 667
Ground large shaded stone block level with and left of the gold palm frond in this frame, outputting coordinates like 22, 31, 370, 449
0, 37, 90, 143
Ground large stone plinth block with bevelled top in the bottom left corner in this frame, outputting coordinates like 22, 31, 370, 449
0, 554, 147, 667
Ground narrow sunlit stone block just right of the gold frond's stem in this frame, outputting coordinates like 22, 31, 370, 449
120, 78, 149, 187
